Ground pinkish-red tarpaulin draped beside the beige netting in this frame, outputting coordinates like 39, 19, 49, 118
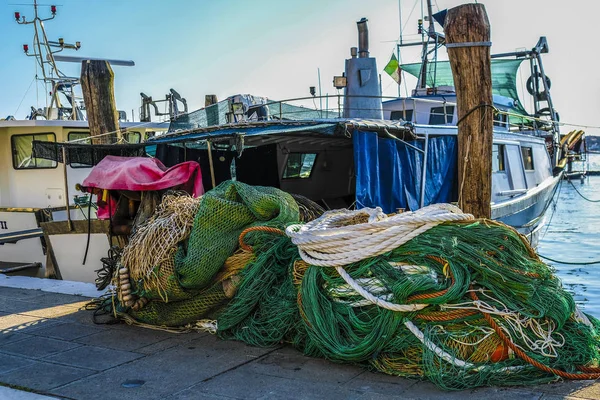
82, 156, 204, 197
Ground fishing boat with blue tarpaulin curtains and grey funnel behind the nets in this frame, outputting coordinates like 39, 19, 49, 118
27, 3, 564, 286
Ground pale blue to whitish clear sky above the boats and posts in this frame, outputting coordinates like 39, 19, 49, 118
0, 0, 600, 134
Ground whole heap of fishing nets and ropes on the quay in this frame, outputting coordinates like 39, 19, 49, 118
104, 181, 600, 389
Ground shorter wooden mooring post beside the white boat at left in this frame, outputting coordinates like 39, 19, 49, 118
81, 60, 119, 144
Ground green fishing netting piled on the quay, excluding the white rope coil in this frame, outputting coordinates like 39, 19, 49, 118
108, 182, 600, 389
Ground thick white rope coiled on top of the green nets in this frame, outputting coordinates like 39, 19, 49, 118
286, 204, 473, 312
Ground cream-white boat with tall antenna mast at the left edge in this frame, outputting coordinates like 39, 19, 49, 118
0, 1, 168, 281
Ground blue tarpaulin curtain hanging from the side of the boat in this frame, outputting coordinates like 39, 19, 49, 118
352, 131, 457, 213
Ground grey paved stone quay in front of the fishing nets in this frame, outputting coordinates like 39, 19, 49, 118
0, 276, 600, 400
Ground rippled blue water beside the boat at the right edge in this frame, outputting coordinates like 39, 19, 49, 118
538, 154, 600, 318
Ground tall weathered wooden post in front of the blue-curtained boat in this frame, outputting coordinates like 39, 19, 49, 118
444, 4, 494, 218
